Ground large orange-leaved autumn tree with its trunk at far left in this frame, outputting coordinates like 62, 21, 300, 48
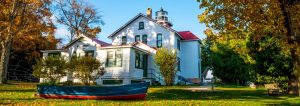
0, 0, 57, 83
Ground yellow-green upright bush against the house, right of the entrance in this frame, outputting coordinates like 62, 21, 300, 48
154, 48, 177, 86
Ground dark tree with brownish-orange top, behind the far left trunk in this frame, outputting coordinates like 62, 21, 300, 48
7, 35, 59, 81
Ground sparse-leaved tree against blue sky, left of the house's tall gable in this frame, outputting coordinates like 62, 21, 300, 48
56, 0, 104, 41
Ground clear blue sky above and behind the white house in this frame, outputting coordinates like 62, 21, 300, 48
56, 0, 206, 43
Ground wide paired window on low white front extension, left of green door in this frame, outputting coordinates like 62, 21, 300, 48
106, 50, 123, 67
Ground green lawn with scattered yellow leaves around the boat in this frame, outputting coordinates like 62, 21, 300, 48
0, 83, 300, 106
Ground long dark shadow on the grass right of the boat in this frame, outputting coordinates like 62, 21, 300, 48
147, 89, 300, 105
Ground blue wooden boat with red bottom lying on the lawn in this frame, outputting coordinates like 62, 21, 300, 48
37, 82, 150, 99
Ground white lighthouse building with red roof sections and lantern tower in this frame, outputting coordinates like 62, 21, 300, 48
42, 8, 201, 85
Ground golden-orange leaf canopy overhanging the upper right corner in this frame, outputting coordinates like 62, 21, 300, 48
198, 0, 300, 44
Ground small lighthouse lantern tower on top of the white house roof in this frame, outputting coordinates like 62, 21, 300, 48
155, 8, 173, 27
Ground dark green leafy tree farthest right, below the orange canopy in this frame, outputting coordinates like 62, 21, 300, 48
247, 35, 294, 89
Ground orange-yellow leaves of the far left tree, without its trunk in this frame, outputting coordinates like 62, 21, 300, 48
0, 0, 56, 61
